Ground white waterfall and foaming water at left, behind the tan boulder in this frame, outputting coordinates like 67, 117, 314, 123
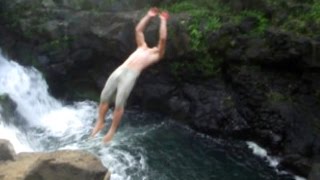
0, 53, 145, 180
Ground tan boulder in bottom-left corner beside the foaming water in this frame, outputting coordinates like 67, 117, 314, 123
0, 140, 110, 180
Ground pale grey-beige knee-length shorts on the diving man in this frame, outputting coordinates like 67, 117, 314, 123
100, 67, 140, 107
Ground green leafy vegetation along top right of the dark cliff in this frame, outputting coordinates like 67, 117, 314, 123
163, 0, 320, 79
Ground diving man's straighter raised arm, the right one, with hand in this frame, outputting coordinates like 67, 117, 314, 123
158, 11, 169, 59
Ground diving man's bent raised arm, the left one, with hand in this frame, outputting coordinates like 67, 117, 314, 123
135, 8, 159, 47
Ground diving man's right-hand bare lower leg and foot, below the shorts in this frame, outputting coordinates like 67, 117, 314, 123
103, 107, 124, 143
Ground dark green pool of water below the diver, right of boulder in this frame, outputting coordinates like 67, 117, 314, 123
80, 111, 293, 180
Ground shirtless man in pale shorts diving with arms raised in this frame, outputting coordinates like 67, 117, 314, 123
91, 8, 169, 142
